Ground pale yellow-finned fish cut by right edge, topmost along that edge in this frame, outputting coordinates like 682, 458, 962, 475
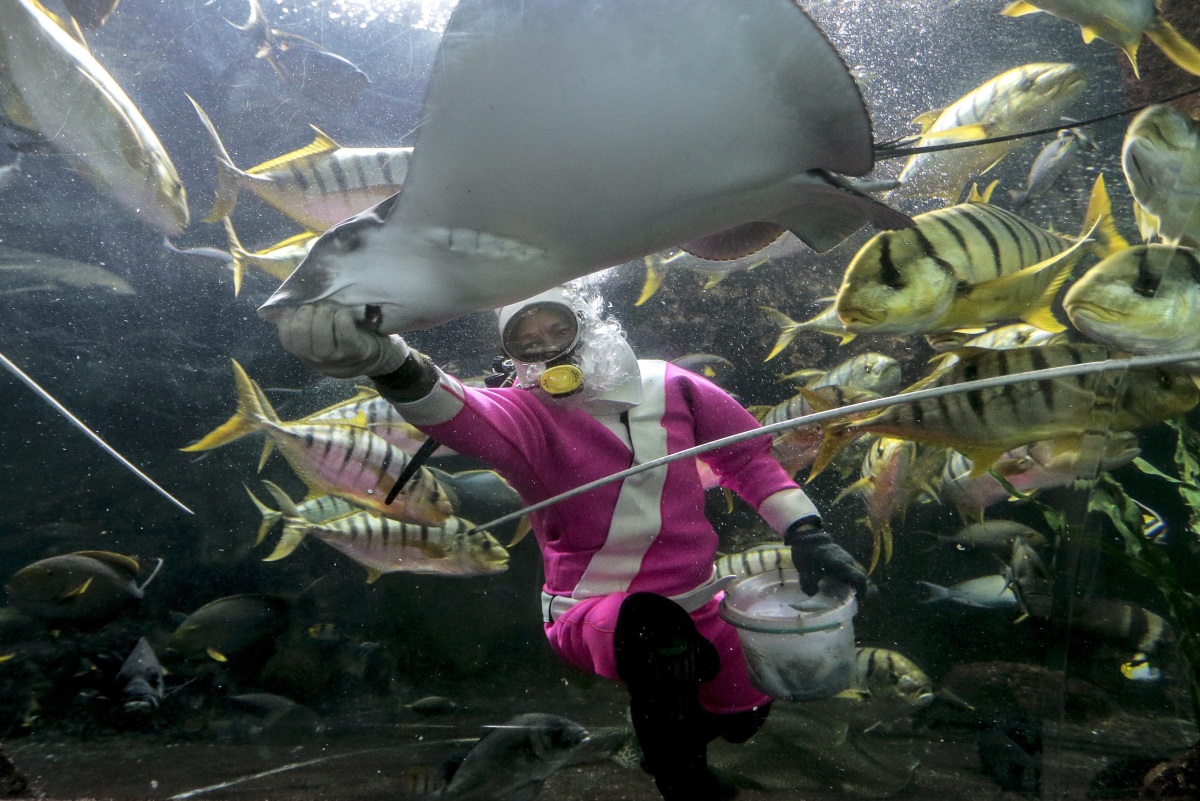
1121, 106, 1200, 246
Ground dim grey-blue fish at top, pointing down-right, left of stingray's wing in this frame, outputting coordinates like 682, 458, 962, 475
234, 0, 371, 112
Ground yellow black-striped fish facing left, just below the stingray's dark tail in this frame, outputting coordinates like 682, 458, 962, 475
835, 177, 1123, 335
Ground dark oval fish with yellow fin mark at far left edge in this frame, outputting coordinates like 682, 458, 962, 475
5, 550, 162, 630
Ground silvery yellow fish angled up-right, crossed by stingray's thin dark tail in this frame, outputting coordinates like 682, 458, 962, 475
889, 64, 1086, 204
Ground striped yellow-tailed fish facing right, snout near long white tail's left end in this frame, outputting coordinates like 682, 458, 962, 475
263, 484, 509, 584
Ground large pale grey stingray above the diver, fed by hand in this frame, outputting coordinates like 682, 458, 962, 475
259, 0, 912, 332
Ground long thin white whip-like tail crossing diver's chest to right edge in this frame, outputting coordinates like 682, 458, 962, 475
472, 350, 1200, 531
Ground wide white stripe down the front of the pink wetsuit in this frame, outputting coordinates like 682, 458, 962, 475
571, 361, 667, 598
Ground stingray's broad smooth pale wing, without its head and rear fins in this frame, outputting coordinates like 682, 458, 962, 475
397, 0, 874, 266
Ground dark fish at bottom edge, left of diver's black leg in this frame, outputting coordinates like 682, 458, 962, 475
437, 712, 589, 801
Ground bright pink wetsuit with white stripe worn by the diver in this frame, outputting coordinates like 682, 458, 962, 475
396, 361, 817, 713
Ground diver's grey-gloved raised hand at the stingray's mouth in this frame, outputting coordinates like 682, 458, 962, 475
275, 303, 409, 378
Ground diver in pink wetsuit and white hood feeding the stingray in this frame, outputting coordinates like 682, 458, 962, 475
276, 287, 866, 801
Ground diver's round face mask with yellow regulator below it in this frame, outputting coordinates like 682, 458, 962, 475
500, 301, 583, 398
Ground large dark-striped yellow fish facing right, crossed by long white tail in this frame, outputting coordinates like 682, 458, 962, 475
800, 344, 1200, 481
